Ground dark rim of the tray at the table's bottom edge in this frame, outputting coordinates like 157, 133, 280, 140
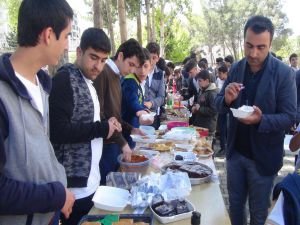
78, 214, 153, 225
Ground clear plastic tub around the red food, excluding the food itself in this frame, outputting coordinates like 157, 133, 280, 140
118, 152, 151, 174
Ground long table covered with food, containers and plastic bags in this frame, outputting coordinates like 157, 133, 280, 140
80, 121, 230, 225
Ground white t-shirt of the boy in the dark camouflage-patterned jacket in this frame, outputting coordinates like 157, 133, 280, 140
70, 76, 103, 199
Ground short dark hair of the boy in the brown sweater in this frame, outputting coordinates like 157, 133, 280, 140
114, 38, 145, 64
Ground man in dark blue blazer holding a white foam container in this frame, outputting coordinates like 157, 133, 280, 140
215, 16, 297, 225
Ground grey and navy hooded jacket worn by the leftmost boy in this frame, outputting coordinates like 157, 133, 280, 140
0, 54, 66, 225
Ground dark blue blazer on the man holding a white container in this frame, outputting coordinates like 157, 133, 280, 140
215, 54, 297, 176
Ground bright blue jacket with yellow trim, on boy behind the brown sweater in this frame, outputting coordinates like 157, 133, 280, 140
122, 74, 146, 128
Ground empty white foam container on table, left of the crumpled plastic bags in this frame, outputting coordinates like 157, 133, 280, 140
93, 186, 130, 212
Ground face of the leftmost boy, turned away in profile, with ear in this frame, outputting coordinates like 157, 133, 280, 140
49, 20, 72, 65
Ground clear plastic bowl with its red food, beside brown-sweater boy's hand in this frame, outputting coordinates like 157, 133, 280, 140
118, 152, 151, 174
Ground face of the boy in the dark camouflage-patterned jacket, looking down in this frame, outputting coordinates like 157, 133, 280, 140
76, 47, 108, 80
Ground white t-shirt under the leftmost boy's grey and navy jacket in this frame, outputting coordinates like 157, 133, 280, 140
15, 72, 44, 116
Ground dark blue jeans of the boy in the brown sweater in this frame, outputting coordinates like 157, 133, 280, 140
100, 143, 121, 185
